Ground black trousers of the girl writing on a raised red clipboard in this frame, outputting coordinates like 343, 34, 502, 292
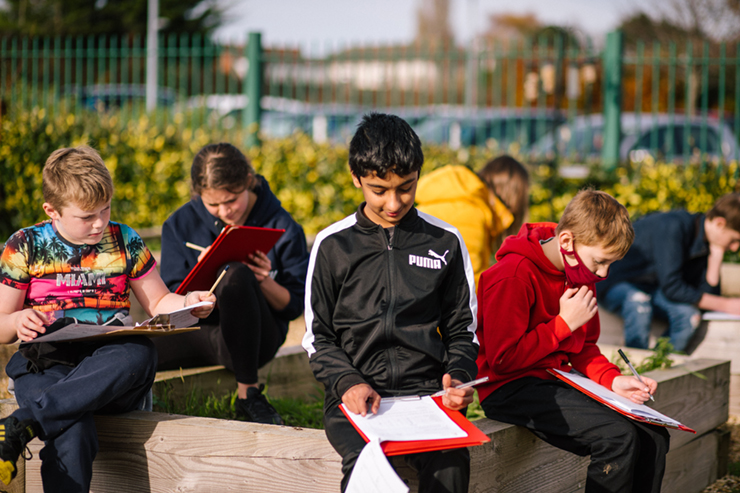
154, 262, 286, 384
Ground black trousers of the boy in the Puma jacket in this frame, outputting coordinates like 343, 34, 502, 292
324, 406, 470, 493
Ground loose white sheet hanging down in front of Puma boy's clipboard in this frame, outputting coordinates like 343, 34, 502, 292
346, 440, 409, 493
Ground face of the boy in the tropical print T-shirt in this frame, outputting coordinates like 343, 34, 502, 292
43, 200, 110, 245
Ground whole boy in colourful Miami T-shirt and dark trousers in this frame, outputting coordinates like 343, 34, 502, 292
0, 146, 216, 493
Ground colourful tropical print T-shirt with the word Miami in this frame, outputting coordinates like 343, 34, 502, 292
0, 219, 155, 324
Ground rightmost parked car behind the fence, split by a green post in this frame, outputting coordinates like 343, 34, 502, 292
530, 113, 738, 163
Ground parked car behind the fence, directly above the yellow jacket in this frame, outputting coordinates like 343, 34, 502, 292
416, 108, 565, 151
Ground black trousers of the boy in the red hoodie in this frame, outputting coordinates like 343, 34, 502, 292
481, 377, 669, 493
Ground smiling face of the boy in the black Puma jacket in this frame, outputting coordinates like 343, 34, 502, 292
352, 171, 419, 228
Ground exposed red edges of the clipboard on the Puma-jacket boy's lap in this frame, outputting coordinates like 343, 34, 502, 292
339, 396, 491, 457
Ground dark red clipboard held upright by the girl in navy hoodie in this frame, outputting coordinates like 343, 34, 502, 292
175, 225, 285, 294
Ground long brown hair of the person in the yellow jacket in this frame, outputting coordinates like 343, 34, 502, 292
478, 154, 529, 241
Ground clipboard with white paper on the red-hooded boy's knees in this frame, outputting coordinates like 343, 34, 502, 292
547, 368, 696, 434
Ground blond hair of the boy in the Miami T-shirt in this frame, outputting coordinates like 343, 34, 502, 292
43, 146, 113, 212
